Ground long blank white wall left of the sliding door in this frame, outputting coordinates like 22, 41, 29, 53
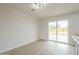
0, 6, 39, 52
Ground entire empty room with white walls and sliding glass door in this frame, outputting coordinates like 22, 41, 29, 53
0, 3, 79, 55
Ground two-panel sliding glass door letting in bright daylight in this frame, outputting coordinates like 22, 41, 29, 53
48, 20, 68, 43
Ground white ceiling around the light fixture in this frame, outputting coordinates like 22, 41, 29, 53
0, 3, 79, 18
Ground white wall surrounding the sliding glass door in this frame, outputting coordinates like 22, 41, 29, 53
40, 12, 79, 44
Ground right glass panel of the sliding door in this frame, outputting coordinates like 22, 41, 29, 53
57, 20, 68, 43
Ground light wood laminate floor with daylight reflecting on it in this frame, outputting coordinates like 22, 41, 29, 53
4, 40, 75, 55
